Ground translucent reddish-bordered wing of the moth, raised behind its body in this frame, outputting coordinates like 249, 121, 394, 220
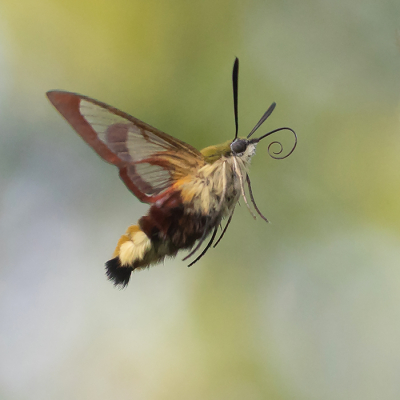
47, 91, 204, 203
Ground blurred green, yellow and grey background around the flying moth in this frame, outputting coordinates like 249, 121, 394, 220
0, 0, 400, 400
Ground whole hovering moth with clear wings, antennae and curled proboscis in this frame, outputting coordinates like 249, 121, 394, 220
47, 58, 297, 287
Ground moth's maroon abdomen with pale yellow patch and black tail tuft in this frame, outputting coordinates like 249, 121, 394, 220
106, 191, 209, 287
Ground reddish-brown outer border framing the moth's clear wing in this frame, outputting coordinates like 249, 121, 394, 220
47, 90, 203, 203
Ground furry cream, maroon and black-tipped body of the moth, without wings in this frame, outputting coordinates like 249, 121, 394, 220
106, 142, 256, 286
